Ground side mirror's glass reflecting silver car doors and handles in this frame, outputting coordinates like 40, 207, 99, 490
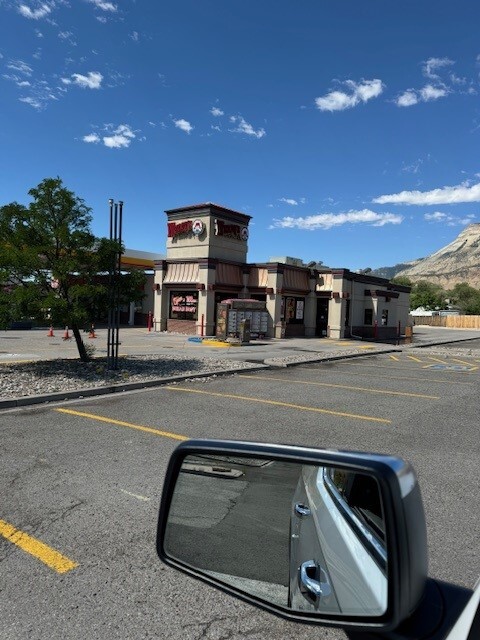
164, 455, 388, 616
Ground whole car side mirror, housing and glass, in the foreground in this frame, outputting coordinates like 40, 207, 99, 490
157, 440, 427, 631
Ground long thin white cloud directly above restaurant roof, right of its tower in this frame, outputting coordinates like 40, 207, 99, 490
270, 209, 403, 231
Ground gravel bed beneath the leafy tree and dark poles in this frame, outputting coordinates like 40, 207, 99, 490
0, 355, 258, 400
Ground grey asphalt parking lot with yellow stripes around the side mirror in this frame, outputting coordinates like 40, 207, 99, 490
0, 349, 480, 640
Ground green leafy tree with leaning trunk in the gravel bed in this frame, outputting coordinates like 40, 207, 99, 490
0, 178, 145, 362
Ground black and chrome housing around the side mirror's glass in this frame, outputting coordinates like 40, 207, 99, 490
157, 440, 427, 632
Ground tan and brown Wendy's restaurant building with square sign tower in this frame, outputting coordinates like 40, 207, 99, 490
153, 202, 410, 340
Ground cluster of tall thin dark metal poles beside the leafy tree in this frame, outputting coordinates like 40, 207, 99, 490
107, 198, 123, 369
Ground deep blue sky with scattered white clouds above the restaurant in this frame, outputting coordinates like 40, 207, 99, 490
0, 0, 480, 270
